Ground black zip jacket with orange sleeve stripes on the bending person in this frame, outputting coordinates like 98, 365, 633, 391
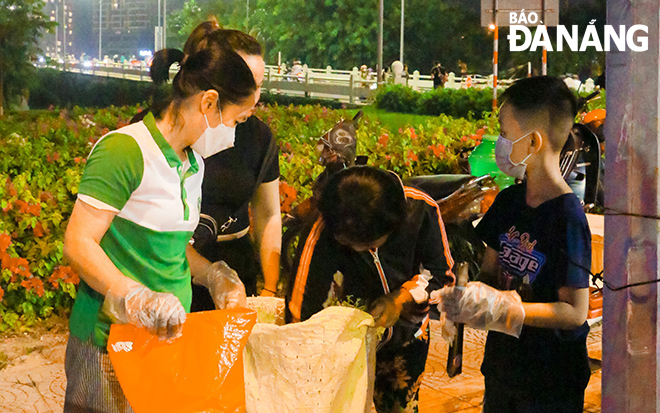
286, 187, 454, 346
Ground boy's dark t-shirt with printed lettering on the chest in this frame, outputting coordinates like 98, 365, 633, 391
477, 183, 591, 396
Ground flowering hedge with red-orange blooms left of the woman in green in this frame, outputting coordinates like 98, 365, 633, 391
0, 107, 137, 331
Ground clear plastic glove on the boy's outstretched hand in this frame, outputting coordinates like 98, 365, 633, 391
440, 282, 525, 337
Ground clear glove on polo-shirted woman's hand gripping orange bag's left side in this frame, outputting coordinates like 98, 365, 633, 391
103, 277, 186, 340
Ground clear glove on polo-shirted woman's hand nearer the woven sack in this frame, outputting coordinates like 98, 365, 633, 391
193, 261, 247, 309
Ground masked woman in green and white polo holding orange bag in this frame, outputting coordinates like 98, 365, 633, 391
64, 27, 258, 413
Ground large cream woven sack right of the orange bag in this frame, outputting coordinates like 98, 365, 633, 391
244, 304, 382, 413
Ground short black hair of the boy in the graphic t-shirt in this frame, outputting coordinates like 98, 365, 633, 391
501, 76, 578, 148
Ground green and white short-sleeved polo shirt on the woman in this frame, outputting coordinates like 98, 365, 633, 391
69, 114, 204, 347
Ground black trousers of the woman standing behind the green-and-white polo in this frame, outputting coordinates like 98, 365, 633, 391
190, 235, 261, 313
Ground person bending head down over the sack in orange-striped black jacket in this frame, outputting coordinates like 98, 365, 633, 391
287, 166, 454, 413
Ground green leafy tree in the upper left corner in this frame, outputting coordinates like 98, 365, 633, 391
0, 0, 55, 114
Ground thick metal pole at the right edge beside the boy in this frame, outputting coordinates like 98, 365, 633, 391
602, 0, 660, 413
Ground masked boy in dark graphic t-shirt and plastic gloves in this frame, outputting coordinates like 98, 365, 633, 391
440, 76, 591, 413
